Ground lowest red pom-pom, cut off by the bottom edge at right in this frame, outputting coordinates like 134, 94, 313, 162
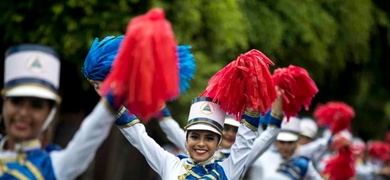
322, 147, 355, 180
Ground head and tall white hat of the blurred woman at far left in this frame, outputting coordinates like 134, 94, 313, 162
2, 44, 61, 149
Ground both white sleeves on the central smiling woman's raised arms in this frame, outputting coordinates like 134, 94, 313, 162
120, 123, 270, 180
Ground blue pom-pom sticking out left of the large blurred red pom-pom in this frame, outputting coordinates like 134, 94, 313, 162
81, 35, 124, 81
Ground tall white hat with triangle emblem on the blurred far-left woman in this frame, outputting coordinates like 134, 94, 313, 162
2, 44, 61, 103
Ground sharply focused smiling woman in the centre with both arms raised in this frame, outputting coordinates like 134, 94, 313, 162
119, 97, 272, 180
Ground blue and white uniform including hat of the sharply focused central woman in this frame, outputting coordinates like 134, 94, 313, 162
120, 98, 278, 180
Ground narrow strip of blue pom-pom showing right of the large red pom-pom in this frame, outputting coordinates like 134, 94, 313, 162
177, 45, 196, 94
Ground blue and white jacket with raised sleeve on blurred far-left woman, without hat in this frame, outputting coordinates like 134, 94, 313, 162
0, 101, 116, 180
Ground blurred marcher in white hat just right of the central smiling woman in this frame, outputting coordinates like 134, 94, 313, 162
247, 117, 322, 180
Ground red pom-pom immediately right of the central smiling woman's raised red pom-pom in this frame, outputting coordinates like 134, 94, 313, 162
272, 65, 318, 120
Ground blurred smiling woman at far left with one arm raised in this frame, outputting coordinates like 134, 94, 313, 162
0, 44, 120, 180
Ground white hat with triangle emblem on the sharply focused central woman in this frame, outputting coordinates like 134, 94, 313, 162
184, 97, 226, 135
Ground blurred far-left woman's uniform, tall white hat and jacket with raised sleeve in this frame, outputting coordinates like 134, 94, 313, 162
0, 44, 116, 180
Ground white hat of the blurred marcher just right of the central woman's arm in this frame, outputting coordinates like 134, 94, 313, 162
276, 117, 301, 141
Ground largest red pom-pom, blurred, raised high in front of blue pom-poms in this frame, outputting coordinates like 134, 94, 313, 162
102, 8, 179, 122
